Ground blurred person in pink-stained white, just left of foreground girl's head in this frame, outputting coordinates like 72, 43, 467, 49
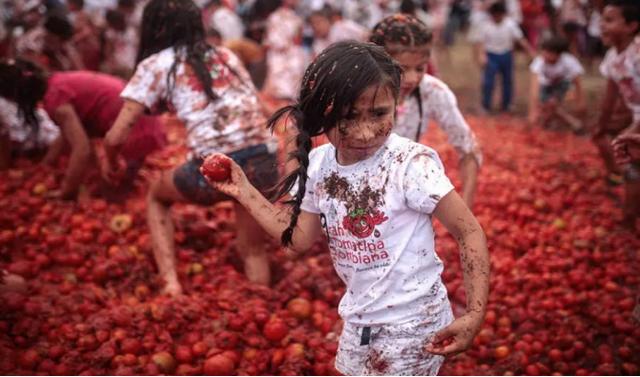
263, 0, 308, 103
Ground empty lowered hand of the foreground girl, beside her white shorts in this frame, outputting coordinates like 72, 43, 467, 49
424, 312, 484, 356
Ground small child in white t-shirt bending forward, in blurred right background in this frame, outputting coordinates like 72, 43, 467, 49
529, 37, 586, 131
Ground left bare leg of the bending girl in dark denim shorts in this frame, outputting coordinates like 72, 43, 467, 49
147, 169, 185, 296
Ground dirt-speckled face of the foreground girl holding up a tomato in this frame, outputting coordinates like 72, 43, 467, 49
327, 85, 396, 165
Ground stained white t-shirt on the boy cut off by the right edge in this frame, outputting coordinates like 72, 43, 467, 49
600, 36, 640, 123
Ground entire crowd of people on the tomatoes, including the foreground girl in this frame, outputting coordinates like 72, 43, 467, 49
0, 0, 640, 374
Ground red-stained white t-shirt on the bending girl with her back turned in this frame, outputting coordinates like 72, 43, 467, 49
121, 47, 271, 156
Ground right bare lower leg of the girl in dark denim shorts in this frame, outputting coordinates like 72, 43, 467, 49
234, 202, 271, 285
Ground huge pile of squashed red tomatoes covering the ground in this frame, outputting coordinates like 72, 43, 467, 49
0, 118, 640, 375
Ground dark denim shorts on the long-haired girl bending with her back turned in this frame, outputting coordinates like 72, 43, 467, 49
173, 144, 279, 205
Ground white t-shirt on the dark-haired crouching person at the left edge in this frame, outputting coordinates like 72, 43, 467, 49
0, 97, 60, 151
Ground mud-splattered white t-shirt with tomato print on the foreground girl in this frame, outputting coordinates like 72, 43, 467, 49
301, 134, 453, 325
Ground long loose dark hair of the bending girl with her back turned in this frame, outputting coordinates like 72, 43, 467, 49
136, 0, 220, 100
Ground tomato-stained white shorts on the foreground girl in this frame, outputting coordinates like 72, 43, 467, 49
336, 305, 454, 376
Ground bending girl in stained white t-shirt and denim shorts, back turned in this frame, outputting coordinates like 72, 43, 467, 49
105, 0, 277, 295
